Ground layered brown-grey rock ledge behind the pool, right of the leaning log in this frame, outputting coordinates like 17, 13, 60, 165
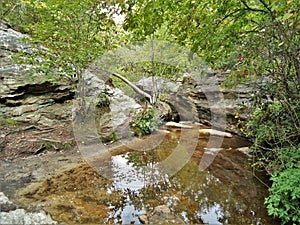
136, 72, 253, 133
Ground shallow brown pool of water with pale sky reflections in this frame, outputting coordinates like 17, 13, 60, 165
15, 130, 279, 225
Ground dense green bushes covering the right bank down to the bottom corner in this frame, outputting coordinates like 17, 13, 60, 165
247, 98, 300, 224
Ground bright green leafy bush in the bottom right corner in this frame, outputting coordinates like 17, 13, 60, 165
265, 165, 300, 225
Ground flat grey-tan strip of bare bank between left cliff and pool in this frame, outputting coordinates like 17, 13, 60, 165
0, 149, 84, 200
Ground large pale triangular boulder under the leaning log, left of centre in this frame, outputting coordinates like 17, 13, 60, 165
73, 70, 142, 143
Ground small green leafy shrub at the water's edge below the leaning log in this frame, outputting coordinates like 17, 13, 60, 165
130, 108, 159, 136
